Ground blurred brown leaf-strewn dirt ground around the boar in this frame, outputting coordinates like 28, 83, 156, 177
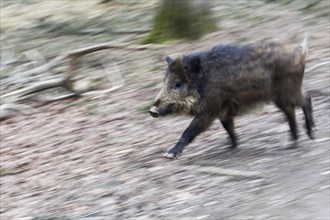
0, 0, 330, 220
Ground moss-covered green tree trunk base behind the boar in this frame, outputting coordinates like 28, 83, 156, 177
142, 0, 217, 44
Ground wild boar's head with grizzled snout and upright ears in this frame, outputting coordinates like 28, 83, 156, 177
149, 55, 203, 117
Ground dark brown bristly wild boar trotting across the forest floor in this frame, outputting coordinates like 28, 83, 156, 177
149, 37, 315, 159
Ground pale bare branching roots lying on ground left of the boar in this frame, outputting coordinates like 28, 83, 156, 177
0, 43, 161, 120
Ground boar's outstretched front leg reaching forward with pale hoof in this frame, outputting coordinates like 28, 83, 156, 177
164, 115, 214, 159
